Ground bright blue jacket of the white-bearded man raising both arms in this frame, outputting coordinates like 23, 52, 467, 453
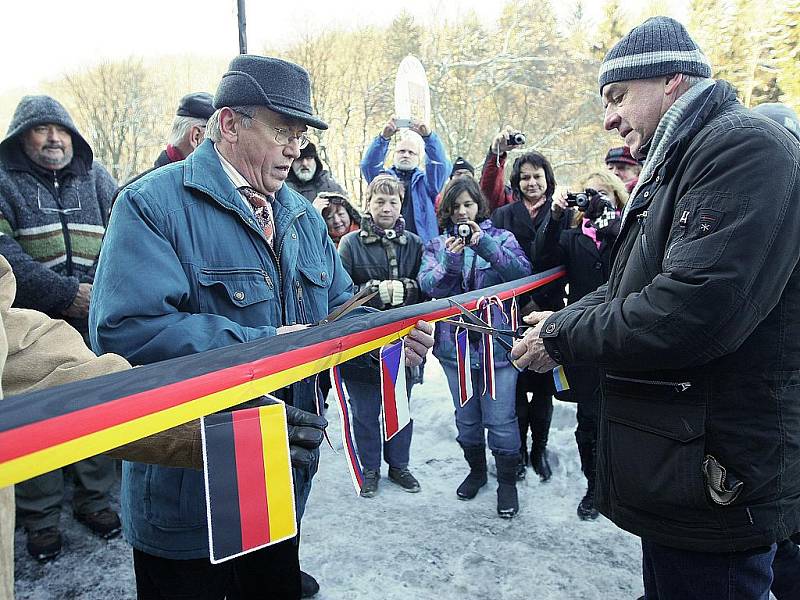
361, 133, 452, 243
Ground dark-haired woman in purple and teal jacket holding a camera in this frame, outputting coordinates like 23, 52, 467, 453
419, 177, 531, 518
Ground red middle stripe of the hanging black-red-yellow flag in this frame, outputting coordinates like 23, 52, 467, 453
232, 408, 270, 551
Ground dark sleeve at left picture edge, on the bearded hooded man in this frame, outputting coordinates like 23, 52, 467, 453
0, 202, 78, 314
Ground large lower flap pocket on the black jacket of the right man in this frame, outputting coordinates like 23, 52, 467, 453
603, 375, 709, 521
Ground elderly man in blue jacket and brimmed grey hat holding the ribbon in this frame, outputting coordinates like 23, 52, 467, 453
90, 55, 433, 600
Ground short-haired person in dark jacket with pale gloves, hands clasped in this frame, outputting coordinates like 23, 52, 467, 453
339, 173, 423, 498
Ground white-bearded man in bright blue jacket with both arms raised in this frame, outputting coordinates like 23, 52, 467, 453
361, 117, 451, 243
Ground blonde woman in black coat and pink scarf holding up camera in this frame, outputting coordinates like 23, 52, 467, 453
534, 171, 628, 521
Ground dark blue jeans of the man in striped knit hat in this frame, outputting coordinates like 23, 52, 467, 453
642, 540, 775, 600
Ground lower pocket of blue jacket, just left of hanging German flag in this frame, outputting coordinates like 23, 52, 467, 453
144, 465, 206, 531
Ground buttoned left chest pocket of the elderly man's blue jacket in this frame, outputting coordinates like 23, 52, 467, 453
197, 268, 275, 316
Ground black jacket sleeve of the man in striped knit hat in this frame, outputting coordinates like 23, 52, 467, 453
542, 127, 800, 370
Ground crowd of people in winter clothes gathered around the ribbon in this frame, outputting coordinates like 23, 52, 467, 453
0, 12, 800, 600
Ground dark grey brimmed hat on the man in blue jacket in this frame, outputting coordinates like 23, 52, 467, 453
214, 54, 328, 129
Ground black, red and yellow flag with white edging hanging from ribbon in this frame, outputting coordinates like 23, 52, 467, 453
202, 402, 297, 564
